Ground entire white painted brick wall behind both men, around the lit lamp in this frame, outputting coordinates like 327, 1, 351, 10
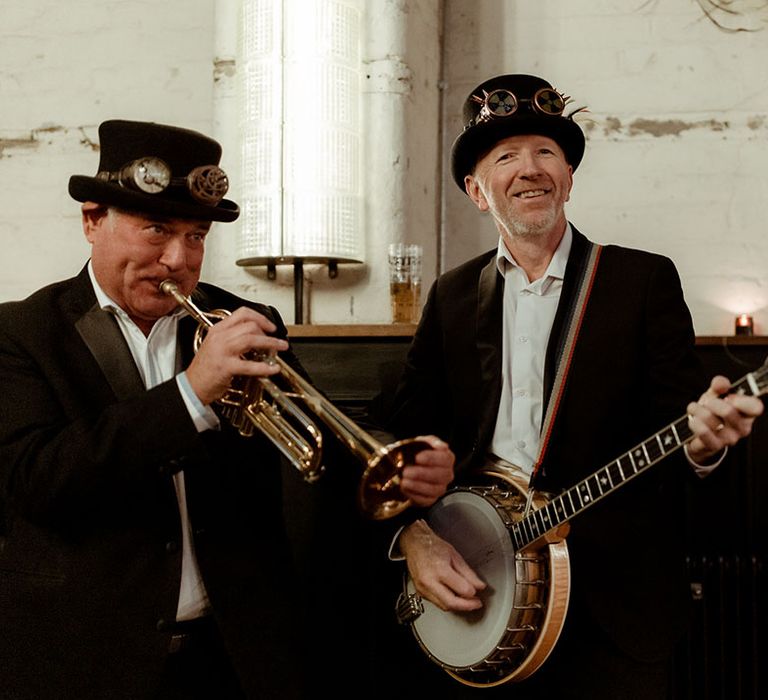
0, 0, 768, 335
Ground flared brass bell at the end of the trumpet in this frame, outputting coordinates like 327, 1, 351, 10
357, 438, 430, 520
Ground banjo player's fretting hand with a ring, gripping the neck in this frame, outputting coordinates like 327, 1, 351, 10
688, 375, 763, 465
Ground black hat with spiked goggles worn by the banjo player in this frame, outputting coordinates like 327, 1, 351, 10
451, 75, 584, 192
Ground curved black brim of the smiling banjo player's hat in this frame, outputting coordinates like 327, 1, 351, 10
451, 116, 584, 192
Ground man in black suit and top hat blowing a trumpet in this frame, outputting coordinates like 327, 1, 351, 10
0, 121, 453, 700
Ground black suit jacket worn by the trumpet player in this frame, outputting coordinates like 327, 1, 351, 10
0, 270, 308, 700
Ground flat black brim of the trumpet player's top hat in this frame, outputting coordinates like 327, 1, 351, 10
69, 175, 240, 222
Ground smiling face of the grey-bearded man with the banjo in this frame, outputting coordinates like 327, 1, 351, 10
464, 134, 573, 246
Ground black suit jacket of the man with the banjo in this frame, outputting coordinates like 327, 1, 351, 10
390, 229, 706, 660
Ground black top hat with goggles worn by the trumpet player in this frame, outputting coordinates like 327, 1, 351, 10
69, 120, 240, 221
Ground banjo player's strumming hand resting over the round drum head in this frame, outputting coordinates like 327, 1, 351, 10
399, 520, 486, 611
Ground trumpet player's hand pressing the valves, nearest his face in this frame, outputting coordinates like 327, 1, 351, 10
187, 307, 288, 405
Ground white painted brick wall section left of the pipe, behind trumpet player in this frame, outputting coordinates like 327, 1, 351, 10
0, 0, 214, 300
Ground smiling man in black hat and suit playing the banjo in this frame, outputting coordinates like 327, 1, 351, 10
389, 75, 763, 700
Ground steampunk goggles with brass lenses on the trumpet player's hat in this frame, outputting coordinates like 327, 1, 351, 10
96, 156, 229, 206
